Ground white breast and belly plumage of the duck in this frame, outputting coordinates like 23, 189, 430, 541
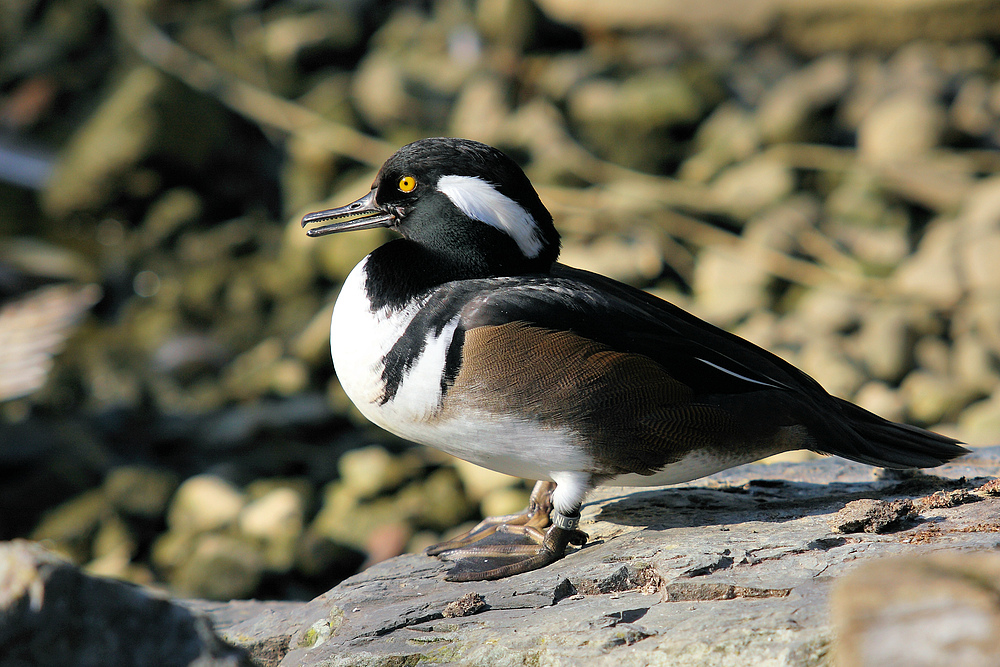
330, 258, 591, 479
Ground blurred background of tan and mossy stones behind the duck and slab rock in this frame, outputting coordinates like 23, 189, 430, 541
0, 0, 1000, 600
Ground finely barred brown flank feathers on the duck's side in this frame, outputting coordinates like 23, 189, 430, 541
449, 321, 740, 476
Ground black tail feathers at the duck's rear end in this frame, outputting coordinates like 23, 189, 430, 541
821, 398, 969, 468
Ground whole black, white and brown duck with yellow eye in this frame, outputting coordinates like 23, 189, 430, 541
302, 138, 968, 581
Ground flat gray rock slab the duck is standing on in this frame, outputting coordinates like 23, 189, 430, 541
195, 447, 1000, 667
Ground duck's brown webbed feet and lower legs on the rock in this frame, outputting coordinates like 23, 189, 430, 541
426, 482, 587, 581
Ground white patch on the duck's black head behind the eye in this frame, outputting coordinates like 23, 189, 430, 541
438, 176, 544, 258
